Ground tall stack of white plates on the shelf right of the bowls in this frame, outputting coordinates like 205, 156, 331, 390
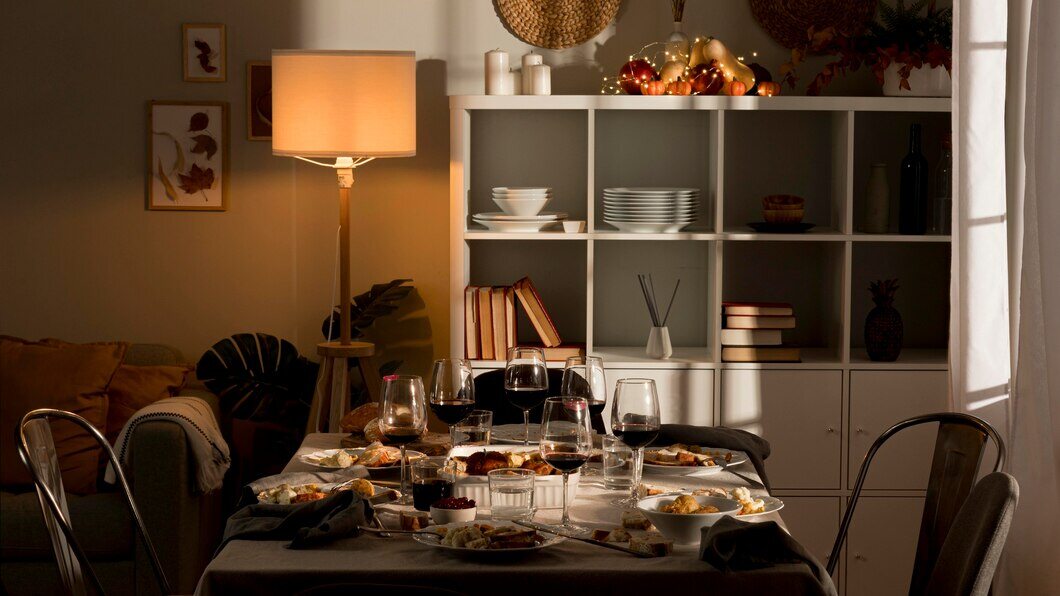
603, 188, 700, 232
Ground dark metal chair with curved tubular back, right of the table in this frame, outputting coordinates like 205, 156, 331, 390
826, 413, 1005, 595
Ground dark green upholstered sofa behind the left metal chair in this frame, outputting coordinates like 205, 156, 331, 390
0, 344, 222, 596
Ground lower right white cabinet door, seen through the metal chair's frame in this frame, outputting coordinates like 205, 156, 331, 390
839, 496, 924, 596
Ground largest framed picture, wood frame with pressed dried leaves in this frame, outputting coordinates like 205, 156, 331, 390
145, 101, 229, 211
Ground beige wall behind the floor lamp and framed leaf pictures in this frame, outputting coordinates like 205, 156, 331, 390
0, 0, 867, 371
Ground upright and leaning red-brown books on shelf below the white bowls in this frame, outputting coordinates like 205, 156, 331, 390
464, 278, 585, 361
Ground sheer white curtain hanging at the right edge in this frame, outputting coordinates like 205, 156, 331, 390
951, 0, 1060, 595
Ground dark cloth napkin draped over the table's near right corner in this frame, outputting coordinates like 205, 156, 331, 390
700, 515, 836, 596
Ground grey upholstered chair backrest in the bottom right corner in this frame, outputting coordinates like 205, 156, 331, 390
925, 472, 1020, 596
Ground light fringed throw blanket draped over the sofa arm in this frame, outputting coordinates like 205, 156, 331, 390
104, 397, 232, 493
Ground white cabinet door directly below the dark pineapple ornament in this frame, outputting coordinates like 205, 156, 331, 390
847, 370, 948, 490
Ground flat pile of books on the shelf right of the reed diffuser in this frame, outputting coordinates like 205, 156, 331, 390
721, 302, 800, 363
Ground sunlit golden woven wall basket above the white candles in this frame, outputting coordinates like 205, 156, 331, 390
494, 0, 622, 50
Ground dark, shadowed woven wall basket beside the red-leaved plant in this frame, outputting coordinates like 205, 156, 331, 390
750, 0, 877, 48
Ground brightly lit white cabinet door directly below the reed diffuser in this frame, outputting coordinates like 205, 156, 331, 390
603, 368, 714, 428
